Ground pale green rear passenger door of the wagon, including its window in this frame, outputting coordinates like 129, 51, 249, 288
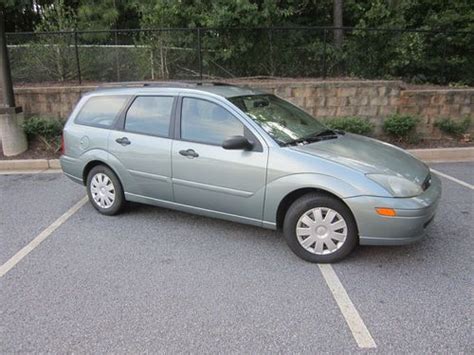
108, 96, 176, 201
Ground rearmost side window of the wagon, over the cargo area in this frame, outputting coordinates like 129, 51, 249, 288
75, 96, 129, 128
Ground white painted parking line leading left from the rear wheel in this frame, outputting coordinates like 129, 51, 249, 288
0, 196, 87, 277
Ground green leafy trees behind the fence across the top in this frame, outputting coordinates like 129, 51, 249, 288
6, 0, 474, 85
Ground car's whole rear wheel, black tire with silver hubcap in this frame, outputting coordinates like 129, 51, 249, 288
87, 165, 125, 216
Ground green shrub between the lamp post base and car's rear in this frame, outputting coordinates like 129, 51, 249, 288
23, 117, 63, 152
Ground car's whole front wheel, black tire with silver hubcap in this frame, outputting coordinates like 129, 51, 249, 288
283, 193, 358, 263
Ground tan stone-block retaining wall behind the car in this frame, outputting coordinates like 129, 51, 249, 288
15, 79, 474, 138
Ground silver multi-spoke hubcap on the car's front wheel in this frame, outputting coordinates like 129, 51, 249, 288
296, 207, 347, 255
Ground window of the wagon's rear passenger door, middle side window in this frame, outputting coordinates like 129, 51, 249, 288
125, 96, 174, 137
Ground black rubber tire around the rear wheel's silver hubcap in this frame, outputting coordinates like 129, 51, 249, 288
87, 165, 125, 216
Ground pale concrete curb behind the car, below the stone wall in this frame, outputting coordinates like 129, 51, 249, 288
0, 147, 474, 171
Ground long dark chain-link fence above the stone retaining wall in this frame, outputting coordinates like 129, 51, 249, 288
7, 27, 474, 85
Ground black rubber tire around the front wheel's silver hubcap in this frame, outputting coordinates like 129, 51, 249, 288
283, 193, 358, 263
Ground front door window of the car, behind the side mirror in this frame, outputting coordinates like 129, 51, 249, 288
181, 97, 244, 145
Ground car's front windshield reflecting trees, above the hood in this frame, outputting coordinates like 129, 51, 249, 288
228, 95, 328, 145
